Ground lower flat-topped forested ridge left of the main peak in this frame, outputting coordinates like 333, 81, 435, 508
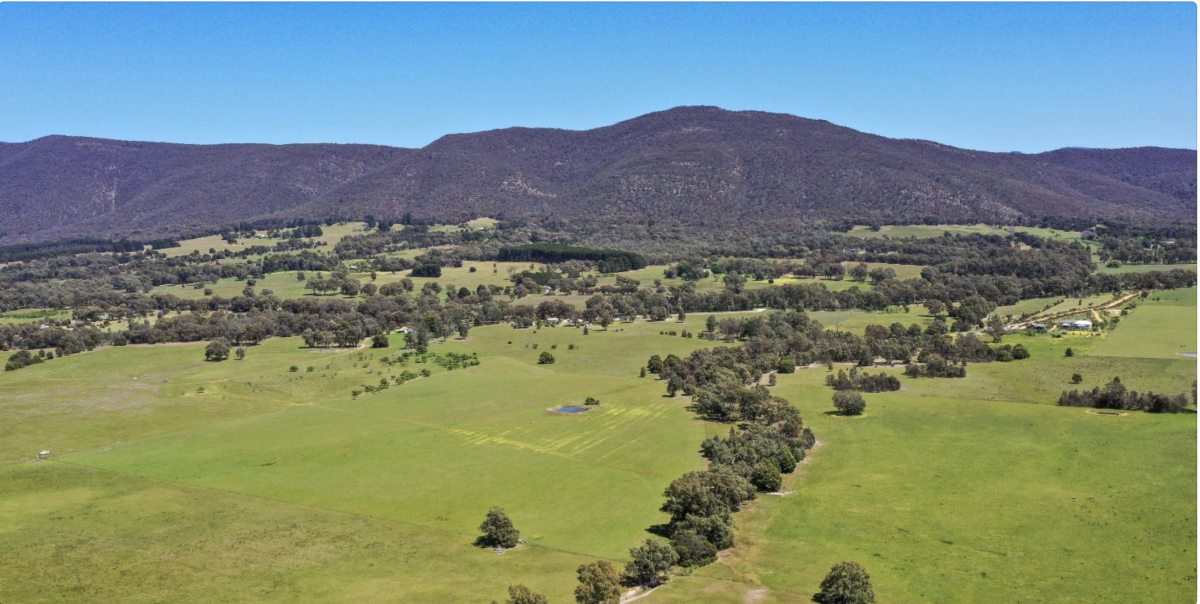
0, 136, 408, 241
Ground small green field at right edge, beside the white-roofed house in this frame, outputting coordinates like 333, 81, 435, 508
1092, 287, 1196, 363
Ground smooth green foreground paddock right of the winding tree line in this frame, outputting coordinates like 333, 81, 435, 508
647, 363, 1196, 604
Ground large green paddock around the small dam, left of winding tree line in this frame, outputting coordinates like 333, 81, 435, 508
0, 317, 739, 603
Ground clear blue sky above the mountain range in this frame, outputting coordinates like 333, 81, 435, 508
0, 2, 1196, 151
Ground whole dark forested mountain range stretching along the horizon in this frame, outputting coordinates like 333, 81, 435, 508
0, 107, 1196, 241
